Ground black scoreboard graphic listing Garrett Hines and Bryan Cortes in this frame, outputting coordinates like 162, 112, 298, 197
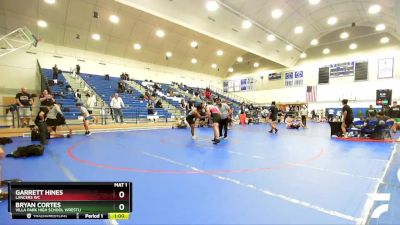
8, 182, 132, 219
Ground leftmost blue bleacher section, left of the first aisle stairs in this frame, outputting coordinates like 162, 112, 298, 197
42, 69, 80, 119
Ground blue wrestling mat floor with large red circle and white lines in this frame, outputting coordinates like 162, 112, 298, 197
0, 123, 400, 225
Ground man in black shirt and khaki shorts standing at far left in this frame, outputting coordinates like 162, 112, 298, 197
15, 87, 33, 127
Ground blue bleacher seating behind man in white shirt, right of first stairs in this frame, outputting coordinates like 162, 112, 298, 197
80, 73, 171, 118
